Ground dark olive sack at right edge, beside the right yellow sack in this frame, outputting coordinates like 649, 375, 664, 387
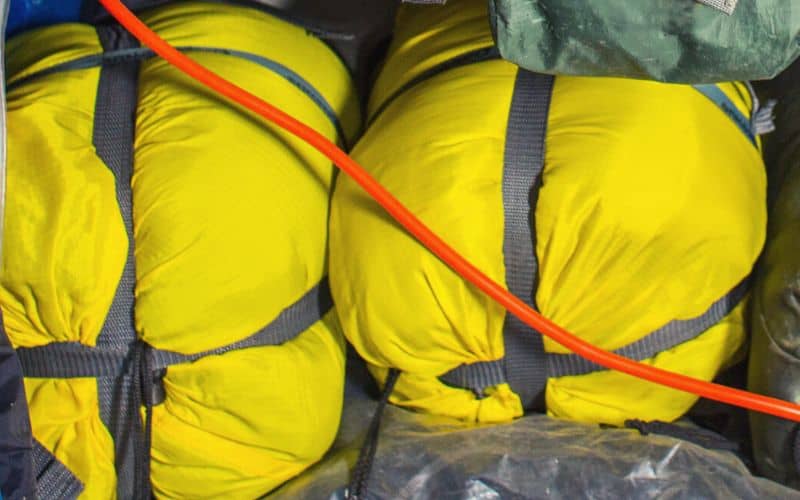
748, 83, 800, 489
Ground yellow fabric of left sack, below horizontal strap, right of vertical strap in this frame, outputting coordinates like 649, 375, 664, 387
151, 312, 344, 498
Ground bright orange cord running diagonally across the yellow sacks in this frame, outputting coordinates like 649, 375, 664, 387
99, 0, 800, 422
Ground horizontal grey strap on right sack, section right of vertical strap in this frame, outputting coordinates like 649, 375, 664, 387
547, 279, 748, 377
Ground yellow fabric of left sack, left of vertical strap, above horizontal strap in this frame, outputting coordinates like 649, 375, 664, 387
0, 35, 122, 347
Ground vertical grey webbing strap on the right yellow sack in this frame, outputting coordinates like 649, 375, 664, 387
496, 68, 554, 409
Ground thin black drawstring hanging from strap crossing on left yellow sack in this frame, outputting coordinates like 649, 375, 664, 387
130, 340, 156, 500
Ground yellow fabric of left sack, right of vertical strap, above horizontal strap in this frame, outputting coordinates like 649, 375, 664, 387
133, 4, 357, 354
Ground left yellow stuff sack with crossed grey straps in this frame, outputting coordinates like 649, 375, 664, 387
0, 2, 360, 499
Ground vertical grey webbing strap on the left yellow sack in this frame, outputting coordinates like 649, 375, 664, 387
92, 24, 140, 498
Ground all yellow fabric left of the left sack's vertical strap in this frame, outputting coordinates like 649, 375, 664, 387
0, 25, 122, 498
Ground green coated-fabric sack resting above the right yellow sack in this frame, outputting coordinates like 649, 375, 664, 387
489, 0, 800, 83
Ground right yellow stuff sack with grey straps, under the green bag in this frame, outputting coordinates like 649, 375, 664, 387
329, 0, 766, 424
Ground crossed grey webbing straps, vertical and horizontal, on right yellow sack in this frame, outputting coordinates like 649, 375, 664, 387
440, 65, 748, 409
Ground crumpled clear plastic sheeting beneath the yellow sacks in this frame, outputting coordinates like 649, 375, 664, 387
273, 362, 800, 500
